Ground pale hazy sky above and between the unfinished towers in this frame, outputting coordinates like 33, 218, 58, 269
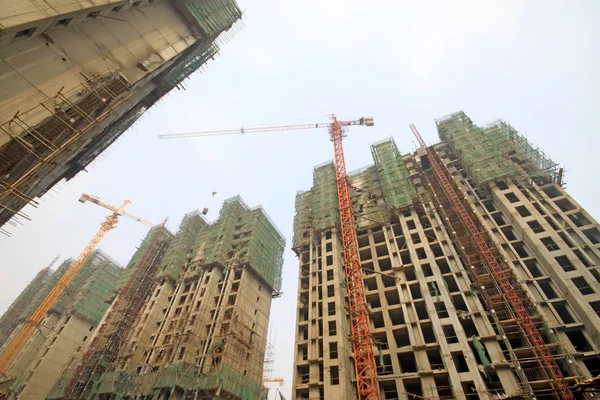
0, 0, 600, 398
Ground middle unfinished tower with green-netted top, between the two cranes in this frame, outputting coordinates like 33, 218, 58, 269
47, 197, 285, 400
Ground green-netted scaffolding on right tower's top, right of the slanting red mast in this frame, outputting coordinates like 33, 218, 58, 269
436, 111, 560, 185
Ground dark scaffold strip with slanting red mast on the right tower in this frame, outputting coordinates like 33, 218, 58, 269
411, 125, 574, 399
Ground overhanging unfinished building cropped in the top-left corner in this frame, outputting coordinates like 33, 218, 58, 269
0, 0, 242, 234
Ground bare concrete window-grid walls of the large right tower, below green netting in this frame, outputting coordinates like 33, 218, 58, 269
292, 144, 600, 400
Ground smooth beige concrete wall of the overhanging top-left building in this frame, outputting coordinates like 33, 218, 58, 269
0, 0, 196, 145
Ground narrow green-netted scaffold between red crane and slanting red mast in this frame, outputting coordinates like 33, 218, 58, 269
371, 138, 417, 209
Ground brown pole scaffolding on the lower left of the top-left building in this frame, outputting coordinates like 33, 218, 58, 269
0, 74, 132, 230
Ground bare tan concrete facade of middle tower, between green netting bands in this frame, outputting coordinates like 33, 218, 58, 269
119, 267, 272, 390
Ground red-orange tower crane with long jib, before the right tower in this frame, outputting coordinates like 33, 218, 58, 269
159, 115, 379, 400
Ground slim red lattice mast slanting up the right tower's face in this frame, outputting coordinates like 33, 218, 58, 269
410, 124, 575, 400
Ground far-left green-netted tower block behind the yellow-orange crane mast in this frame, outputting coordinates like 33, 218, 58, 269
0, 250, 123, 399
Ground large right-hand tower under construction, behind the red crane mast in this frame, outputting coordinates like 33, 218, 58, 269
292, 112, 600, 400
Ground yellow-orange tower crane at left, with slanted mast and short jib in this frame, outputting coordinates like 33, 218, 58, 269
0, 193, 153, 375
